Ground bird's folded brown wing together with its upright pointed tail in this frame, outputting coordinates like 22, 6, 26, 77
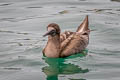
61, 16, 90, 57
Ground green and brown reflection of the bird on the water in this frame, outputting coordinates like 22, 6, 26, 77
42, 50, 89, 80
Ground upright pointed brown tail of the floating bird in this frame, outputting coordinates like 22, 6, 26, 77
76, 15, 90, 33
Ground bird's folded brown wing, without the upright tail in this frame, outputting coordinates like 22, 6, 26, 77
61, 33, 89, 57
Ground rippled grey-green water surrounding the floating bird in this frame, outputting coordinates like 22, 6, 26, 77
0, 0, 120, 80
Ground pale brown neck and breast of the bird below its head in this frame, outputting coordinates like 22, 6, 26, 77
45, 35, 60, 57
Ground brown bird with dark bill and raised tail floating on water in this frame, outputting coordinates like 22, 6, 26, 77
42, 15, 90, 58
